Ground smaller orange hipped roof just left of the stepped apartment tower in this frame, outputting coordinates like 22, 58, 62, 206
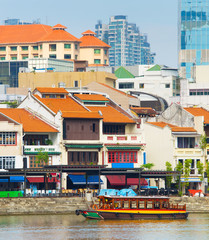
80, 30, 111, 48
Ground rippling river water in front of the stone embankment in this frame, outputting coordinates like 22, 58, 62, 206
0, 214, 209, 240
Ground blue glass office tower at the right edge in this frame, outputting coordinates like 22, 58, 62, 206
178, 0, 209, 82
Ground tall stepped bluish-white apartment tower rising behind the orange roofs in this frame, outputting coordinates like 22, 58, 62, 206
95, 15, 154, 66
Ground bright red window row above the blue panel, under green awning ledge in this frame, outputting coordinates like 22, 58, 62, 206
108, 151, 137, 163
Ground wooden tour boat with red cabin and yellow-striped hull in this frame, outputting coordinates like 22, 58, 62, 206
76, 196, 188, 220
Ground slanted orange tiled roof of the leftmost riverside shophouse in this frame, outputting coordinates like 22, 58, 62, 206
0, 108, 58, 133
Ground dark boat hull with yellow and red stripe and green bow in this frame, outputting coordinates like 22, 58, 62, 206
76, 209, 188, 220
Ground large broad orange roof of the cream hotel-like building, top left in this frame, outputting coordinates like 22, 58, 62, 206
0, 24, 79, 44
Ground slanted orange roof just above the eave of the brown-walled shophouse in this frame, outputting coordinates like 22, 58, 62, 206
34, 95, 88, 113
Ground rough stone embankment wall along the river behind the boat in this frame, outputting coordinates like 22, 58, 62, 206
0, 197, 209, 215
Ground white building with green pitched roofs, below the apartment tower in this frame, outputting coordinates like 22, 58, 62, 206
115, 65, 180, 102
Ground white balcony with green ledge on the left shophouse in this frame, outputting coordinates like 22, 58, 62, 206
24, 145, 61, 155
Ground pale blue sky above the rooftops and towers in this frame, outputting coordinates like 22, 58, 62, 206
0, 0, 178, 68
